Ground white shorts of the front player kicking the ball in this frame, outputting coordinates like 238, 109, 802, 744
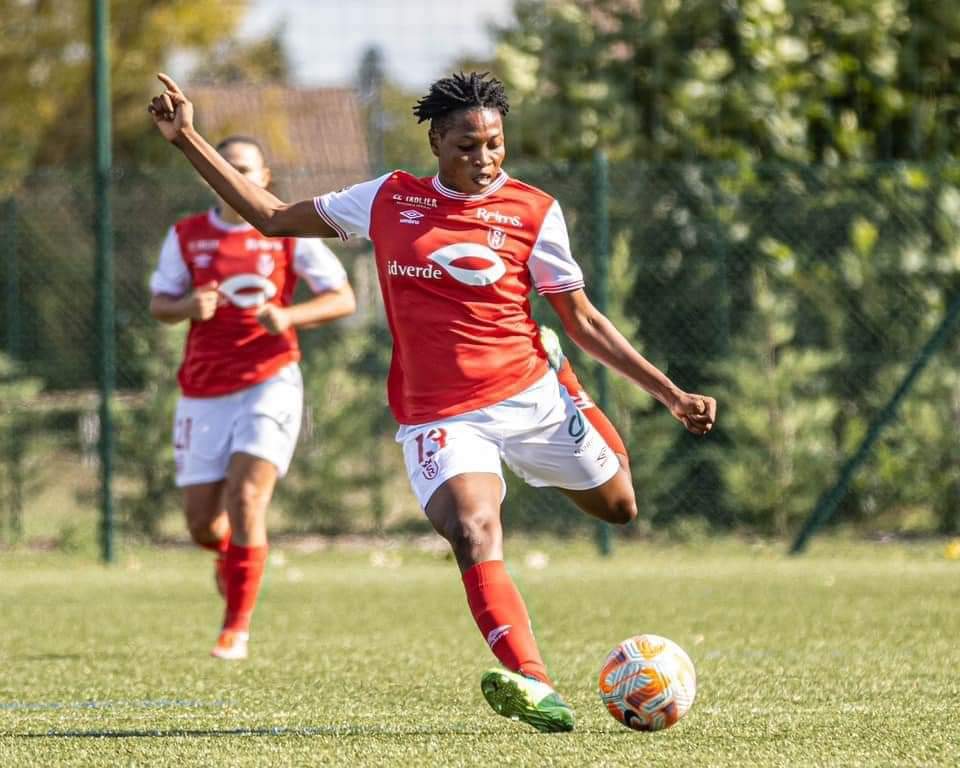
397, 370, 620, 508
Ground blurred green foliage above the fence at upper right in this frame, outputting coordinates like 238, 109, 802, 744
497, 0, 960, 162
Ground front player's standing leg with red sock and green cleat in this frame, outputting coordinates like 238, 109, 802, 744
426, 473, 574, 732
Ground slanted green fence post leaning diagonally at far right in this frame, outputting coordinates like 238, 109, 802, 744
790, 295, 960, 555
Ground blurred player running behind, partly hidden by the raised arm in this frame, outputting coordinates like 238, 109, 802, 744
150, 136, 355, 659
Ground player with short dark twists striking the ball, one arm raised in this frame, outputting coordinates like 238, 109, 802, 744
149, 73, 716, 731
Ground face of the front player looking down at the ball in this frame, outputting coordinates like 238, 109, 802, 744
430, 109, 506, 195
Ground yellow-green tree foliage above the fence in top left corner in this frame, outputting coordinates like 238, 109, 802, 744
0, 0, 253, 177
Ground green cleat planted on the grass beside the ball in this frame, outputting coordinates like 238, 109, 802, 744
480, 669, 575, 733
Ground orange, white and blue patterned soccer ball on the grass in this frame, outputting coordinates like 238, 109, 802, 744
600, 635, 697, 731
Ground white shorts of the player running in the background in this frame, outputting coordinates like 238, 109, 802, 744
173, 363, 303, 487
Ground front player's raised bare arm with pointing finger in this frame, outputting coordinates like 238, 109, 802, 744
147, 74, 337, 237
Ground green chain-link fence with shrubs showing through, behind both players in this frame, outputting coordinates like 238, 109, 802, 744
0, 162, 960, 539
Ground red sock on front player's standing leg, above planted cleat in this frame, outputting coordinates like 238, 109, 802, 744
463, 560, 553, 685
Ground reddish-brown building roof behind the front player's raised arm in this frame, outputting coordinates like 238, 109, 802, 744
187, 85, 371, 200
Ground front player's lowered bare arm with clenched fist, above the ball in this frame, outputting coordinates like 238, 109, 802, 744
547, 290, 717, 435
